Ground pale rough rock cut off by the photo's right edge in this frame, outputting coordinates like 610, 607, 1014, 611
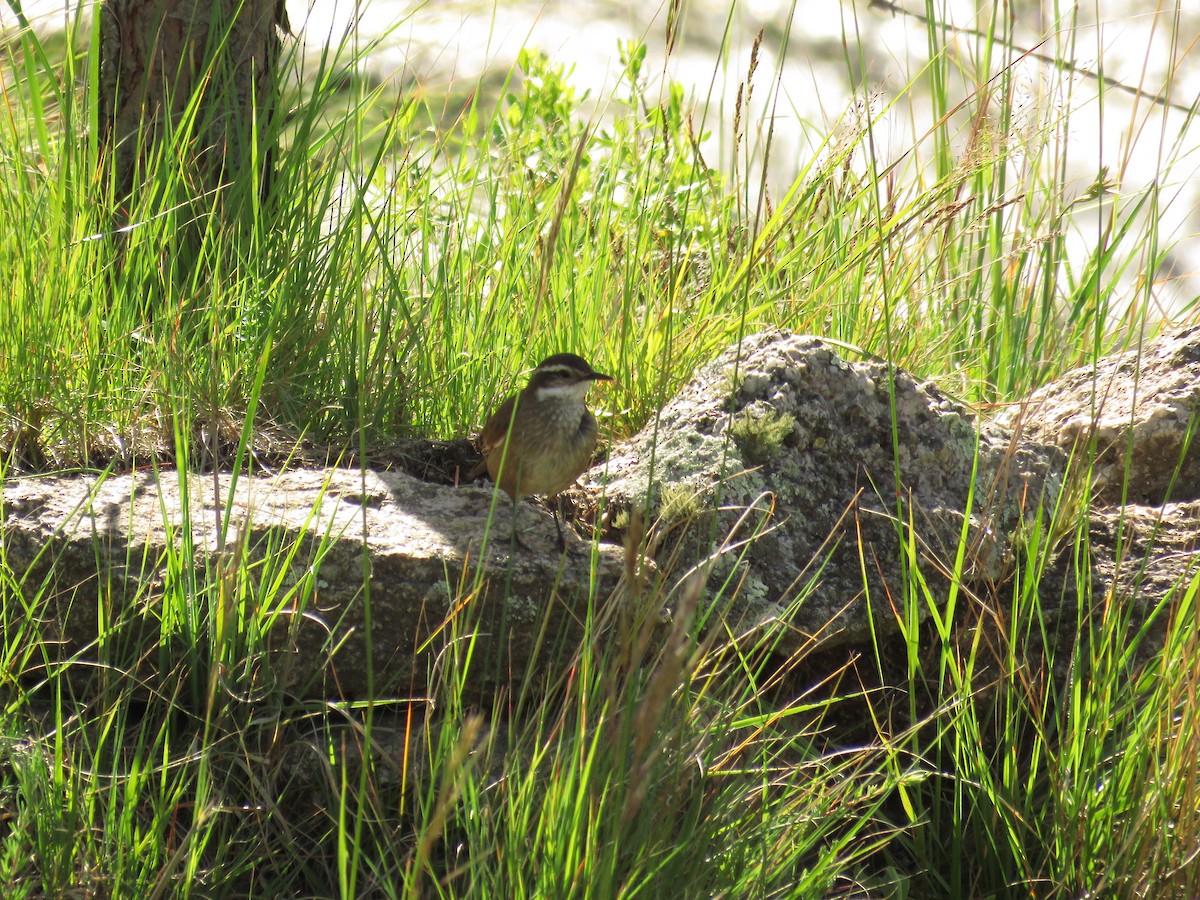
988, 326, 1200, 658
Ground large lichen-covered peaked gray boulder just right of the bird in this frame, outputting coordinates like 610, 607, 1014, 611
587, 332, 1061, 649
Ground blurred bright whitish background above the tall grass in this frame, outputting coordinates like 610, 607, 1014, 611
9, 0, 1200, 318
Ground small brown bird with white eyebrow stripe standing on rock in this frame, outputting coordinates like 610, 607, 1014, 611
468, 353, 612, 548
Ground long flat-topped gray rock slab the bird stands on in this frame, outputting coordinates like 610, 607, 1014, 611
0, 469, 623, 697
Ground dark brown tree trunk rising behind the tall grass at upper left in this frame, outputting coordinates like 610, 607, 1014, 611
98, 0, 288, 205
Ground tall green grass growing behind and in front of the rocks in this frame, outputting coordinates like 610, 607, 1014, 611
0, 5, 1200, 898
